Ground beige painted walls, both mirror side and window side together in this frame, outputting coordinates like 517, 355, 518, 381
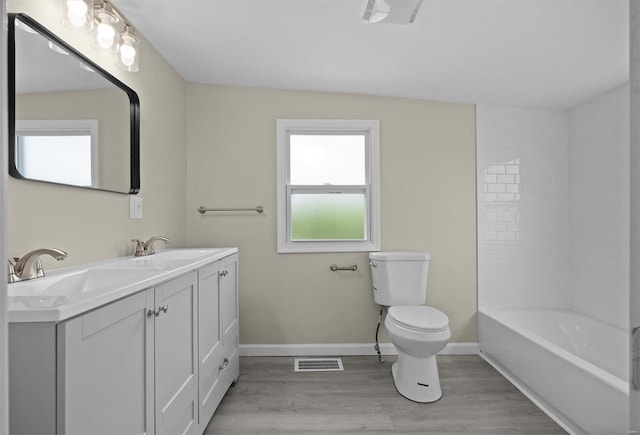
8, 0, 476, 344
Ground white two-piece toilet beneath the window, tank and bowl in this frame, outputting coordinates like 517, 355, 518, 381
369, 251, 451, 402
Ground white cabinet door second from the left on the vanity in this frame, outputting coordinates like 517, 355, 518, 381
154, 272, 198, 433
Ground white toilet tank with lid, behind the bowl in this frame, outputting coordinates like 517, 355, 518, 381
369, 251, 431, 306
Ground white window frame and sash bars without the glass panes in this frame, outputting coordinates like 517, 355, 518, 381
276, 119, 380, 253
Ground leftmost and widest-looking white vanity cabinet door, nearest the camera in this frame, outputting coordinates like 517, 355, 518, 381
57, 290, 154, 434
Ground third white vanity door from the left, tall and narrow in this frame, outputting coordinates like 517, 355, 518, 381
198, 261, 222, 425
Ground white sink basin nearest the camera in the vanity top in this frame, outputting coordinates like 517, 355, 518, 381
8, 267, 163, 297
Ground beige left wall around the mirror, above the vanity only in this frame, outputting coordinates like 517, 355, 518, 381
7, 0, 186, 268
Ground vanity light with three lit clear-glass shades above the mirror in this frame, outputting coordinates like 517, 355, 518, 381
61, 0, 140, 72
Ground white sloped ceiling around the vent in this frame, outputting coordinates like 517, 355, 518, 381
113, 0, 629, 107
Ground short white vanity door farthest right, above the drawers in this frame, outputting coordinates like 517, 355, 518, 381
220, 254, 238, 345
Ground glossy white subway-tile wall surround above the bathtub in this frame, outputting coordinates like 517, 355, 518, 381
476, 86, 629, 327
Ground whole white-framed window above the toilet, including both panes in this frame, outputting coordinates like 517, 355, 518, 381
277, 119, 380, 252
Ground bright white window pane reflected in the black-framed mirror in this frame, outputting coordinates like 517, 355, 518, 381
16, 136, 91, 186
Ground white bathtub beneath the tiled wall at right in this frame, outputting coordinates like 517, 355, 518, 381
478, 310, 629, 435
